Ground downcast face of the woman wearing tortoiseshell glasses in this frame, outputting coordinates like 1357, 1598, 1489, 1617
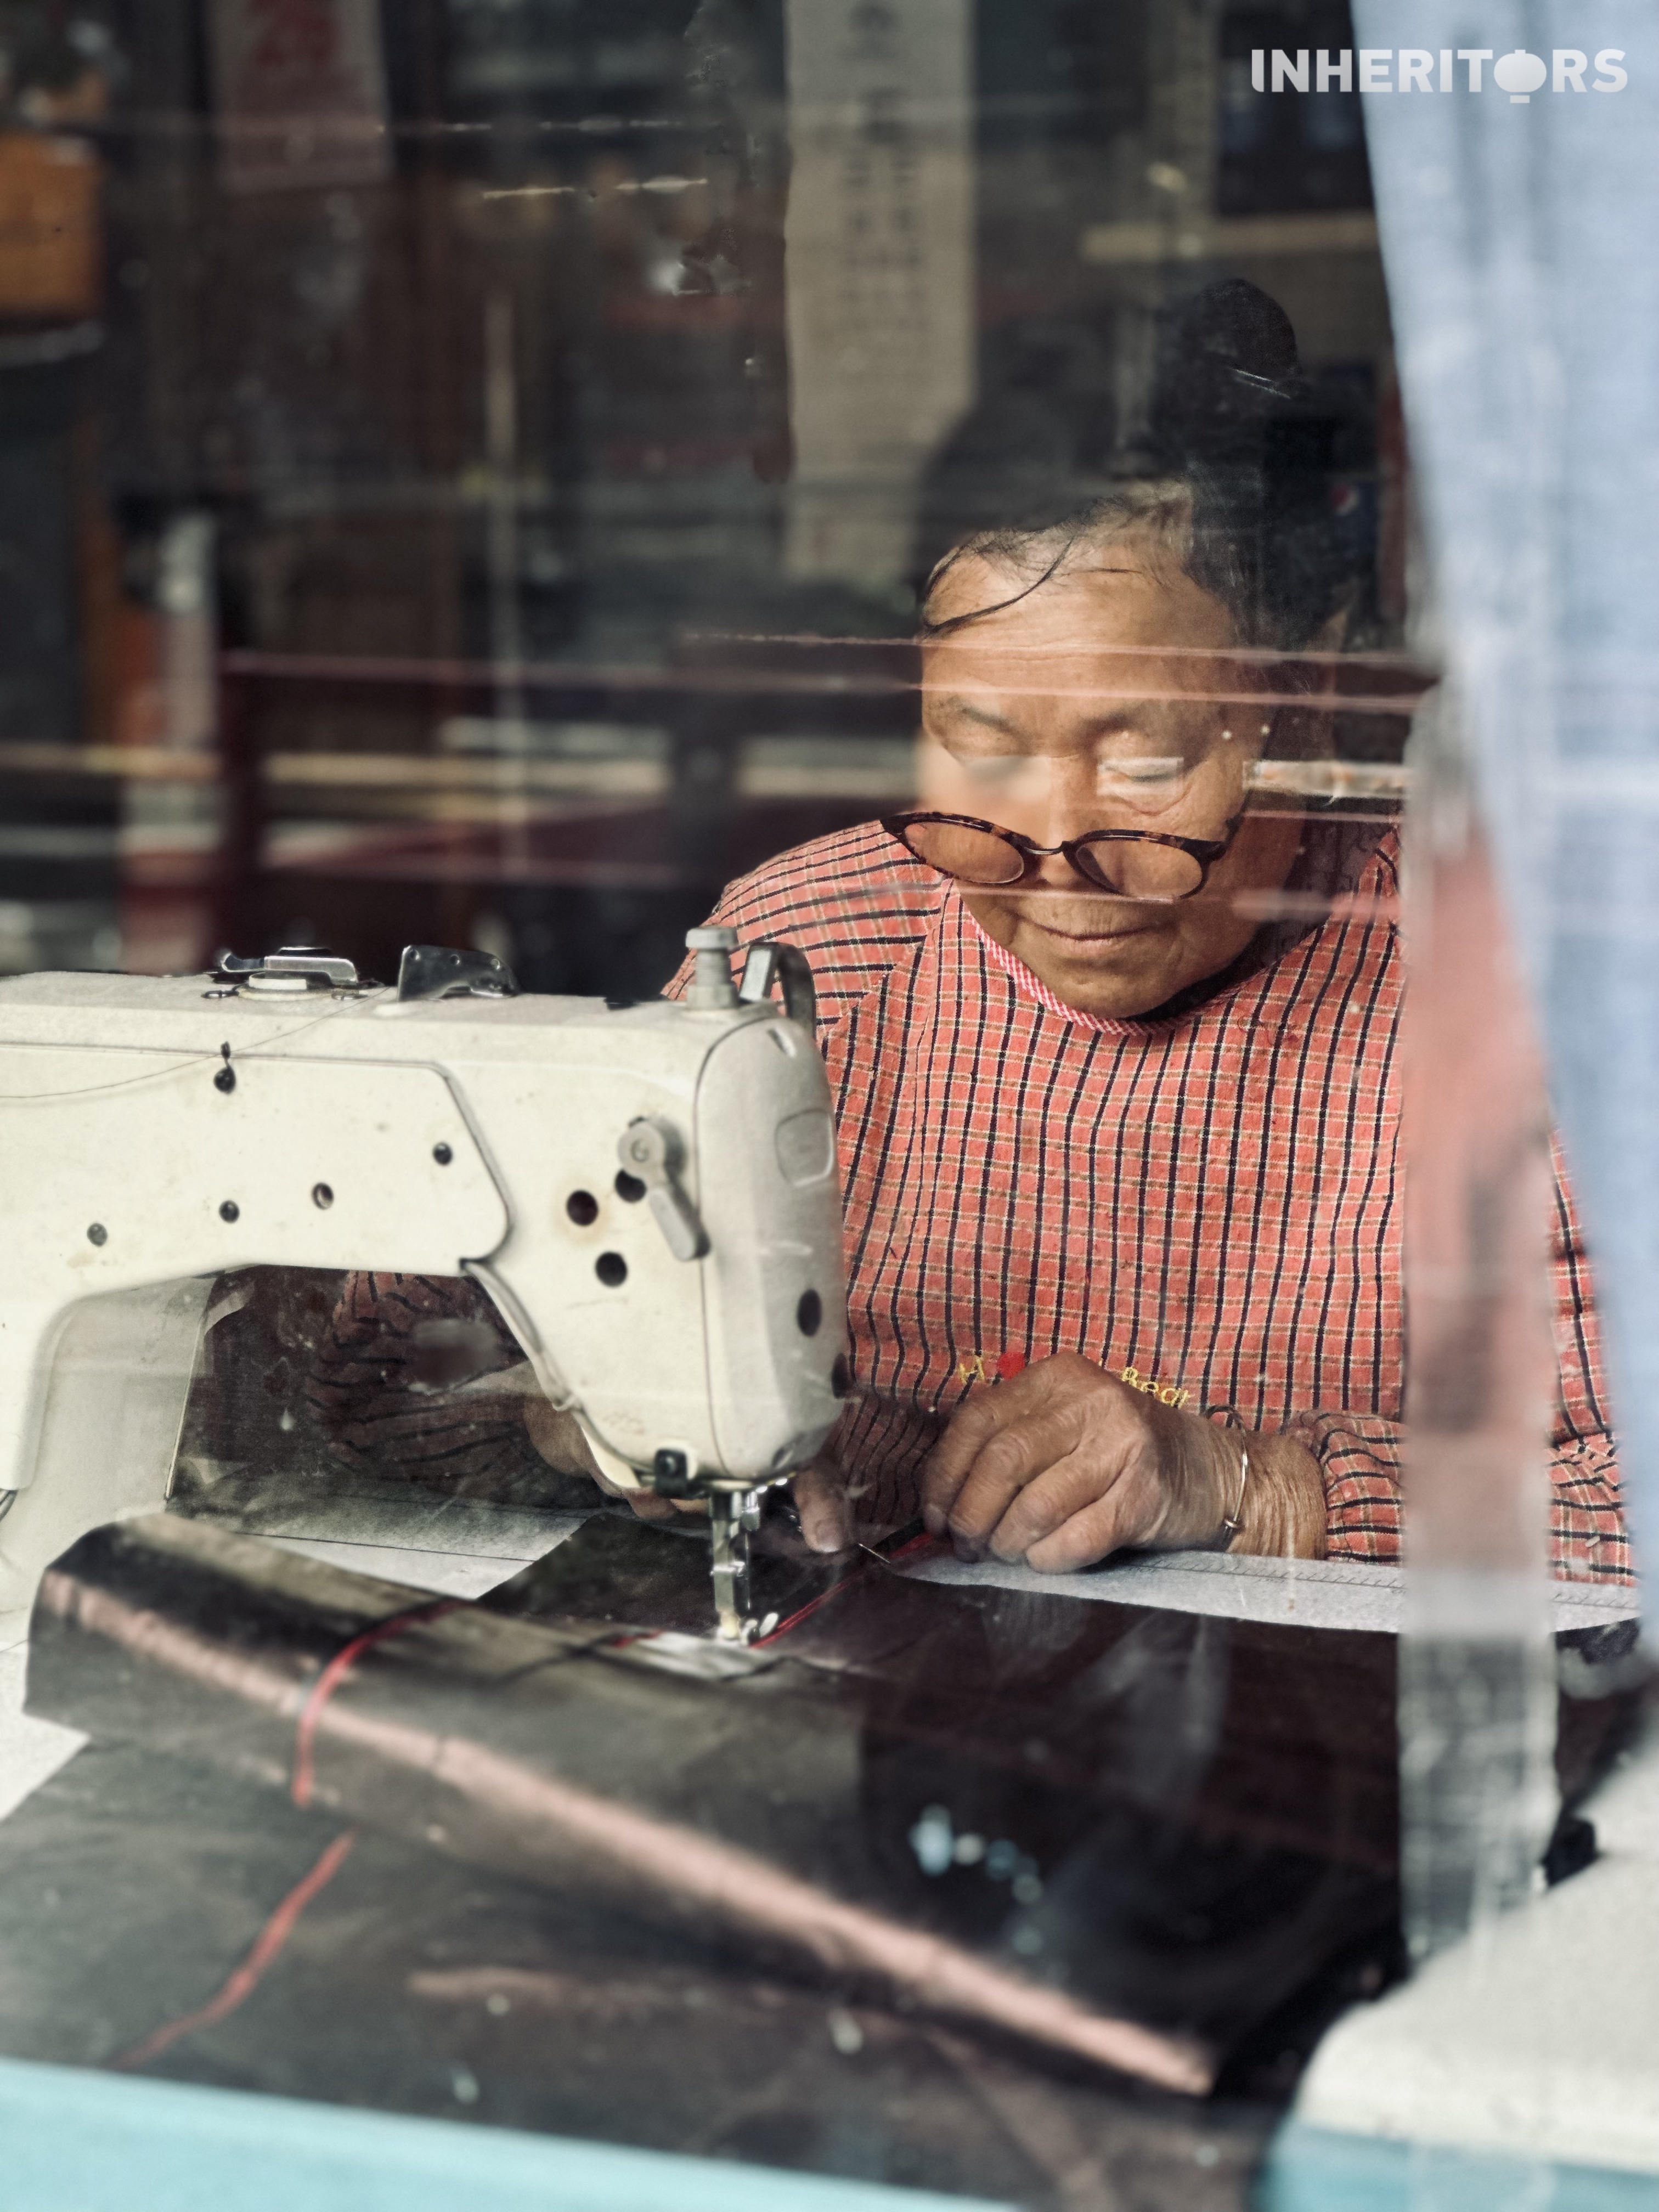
918, 538, 1301, 1020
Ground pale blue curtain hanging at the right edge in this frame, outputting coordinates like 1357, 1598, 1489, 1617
1353, 0, 1659, 1604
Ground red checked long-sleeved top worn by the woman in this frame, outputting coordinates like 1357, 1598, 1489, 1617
681, 823, 1630, 1579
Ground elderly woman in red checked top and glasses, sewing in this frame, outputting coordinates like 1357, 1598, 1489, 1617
309, 285, 1628, 1577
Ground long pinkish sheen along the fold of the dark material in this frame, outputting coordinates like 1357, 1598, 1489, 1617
40, 1573, 1215, 2095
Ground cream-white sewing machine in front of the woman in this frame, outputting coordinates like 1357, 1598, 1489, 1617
0, 929, 847, 1639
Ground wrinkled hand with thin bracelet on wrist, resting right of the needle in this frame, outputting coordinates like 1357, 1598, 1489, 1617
922, 1352, 1325, 1573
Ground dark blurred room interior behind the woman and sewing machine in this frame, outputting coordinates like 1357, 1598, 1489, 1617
0, 0, 1409, 993
